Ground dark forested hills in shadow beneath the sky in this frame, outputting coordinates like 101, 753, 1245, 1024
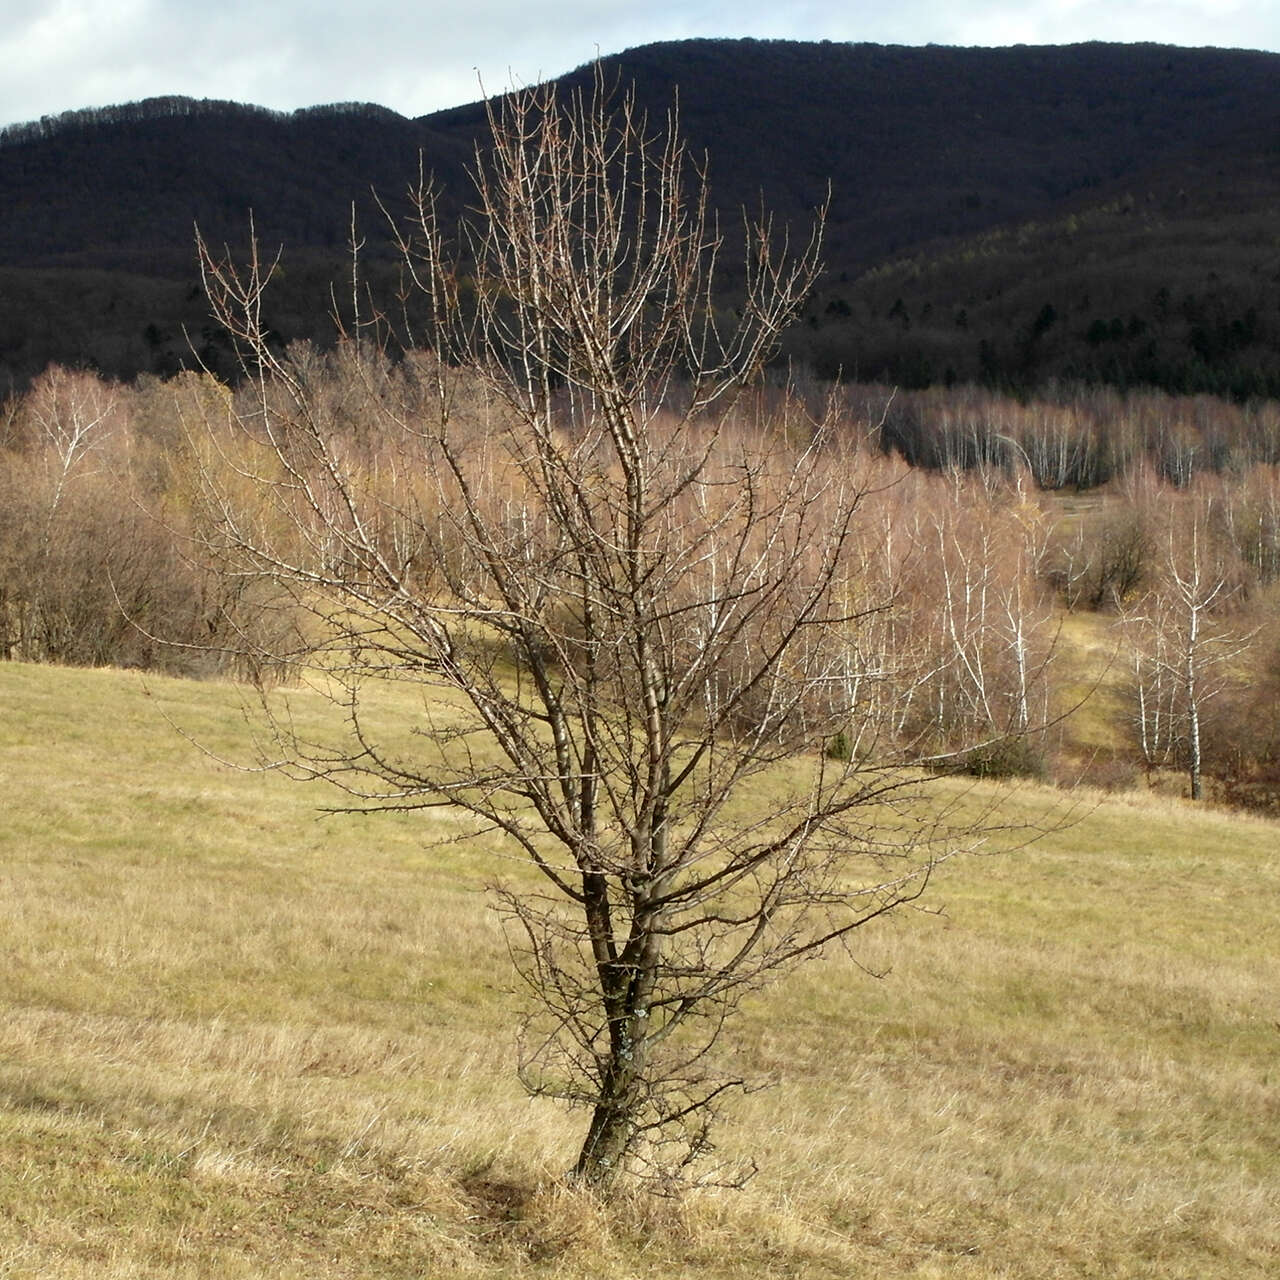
0, 41, 1280, 396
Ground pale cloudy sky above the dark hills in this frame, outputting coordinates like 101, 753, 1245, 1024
0, 0, 1280, 124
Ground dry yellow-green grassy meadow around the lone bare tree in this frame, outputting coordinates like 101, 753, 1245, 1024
0, 664, 1280, 1280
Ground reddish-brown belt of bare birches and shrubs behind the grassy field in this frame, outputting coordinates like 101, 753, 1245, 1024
0, 346, 1280, 805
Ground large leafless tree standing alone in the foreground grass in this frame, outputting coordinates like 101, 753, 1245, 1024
196, 76, 1003, 1184
